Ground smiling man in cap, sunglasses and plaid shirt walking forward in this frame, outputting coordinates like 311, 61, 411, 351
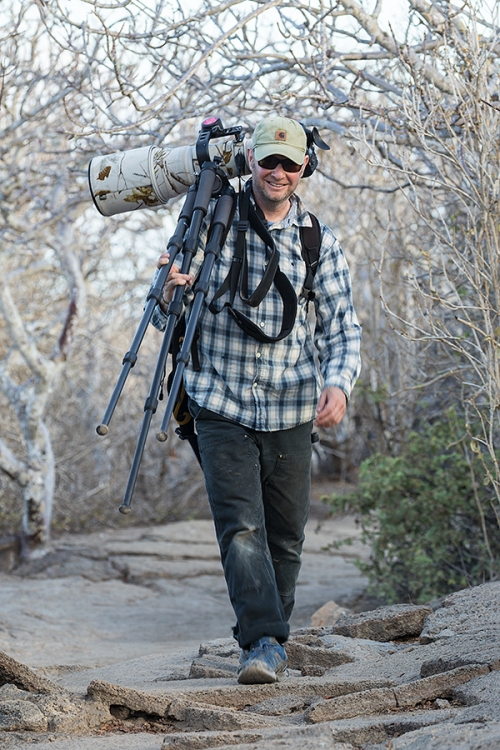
153, 117, 360, 684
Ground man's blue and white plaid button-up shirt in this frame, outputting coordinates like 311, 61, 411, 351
152, 196, 361, 432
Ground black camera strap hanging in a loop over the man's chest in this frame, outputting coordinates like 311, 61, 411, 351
209, 181, 297, 344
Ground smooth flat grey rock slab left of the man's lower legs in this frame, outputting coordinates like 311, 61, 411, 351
0, 575, 234, 667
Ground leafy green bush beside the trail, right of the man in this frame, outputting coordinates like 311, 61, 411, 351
329, 415, 500, 602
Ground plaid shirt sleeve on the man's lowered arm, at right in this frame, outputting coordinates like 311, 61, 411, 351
314, 224, 361, 398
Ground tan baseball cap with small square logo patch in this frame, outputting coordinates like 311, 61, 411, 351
252, 117, 307, 164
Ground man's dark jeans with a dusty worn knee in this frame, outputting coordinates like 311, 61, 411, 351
190, 400, 312, 648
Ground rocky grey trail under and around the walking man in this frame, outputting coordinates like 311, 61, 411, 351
0, 502, 500, 750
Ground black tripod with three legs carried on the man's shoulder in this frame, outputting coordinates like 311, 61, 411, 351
96, 124, 241, 514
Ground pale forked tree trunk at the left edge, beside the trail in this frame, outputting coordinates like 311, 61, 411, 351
0, 214, 85, 556
